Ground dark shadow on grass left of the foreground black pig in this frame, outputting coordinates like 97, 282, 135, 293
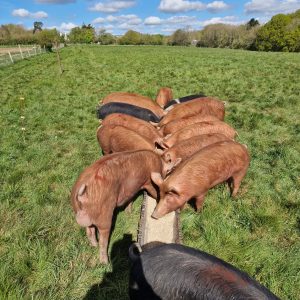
83, 234, 133, 300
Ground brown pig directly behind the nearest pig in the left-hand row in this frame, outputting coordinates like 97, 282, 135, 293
97, 125, 155, 155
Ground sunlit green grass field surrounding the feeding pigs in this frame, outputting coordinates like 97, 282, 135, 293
0, 46, 300, 299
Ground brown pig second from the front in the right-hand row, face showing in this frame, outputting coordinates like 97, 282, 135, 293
162, 133, 229, 176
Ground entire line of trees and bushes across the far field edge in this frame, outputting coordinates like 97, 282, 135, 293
0, 10, 300, 52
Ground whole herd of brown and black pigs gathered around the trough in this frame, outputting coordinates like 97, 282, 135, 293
71, 88, 278, 300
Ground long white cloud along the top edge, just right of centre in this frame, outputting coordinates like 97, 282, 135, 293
158, 0, 229, 13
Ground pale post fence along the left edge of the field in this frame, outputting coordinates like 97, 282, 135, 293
0, 44, 64, 67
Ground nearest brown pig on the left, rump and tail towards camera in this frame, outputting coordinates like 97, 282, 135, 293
71, 150, 162, 263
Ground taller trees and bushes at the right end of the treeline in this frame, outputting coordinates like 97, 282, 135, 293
197, 10, 300, 52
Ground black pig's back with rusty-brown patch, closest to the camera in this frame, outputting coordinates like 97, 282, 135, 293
130, 244, 278, 300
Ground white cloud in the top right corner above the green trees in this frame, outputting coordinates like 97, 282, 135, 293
245, 0, 300, 15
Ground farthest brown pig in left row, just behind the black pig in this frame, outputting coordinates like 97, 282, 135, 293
102, 92, 164, 118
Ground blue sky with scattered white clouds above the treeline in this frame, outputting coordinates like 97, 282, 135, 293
0, 0, 300, 35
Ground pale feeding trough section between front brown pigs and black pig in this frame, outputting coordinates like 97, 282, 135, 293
137, 192, 181, 246
